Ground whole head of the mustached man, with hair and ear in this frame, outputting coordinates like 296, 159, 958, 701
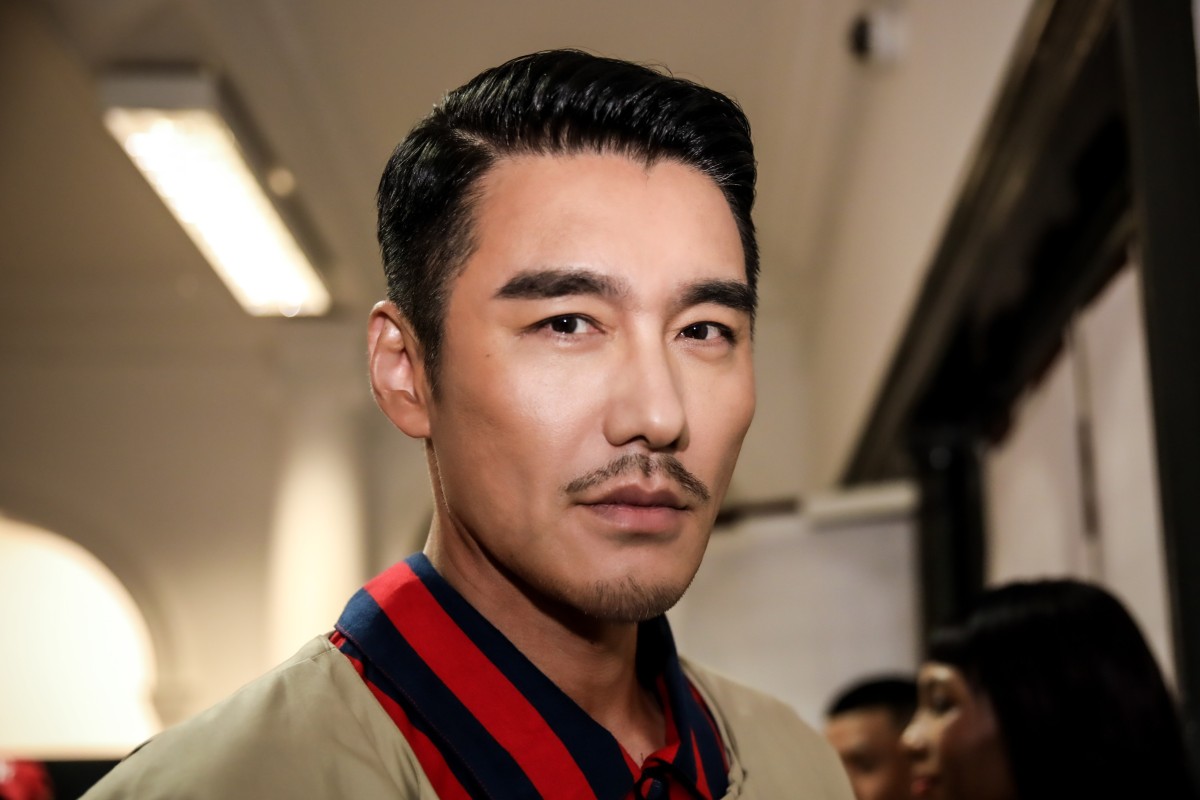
368, 52, 757, 622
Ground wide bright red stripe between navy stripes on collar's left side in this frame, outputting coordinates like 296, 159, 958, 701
366, 563, 594, 798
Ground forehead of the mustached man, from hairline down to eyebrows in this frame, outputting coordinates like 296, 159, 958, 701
456, 152, 752, 299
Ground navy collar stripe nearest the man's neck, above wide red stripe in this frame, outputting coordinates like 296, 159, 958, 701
404, 553, 634, 800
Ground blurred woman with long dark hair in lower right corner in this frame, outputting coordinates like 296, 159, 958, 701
904, 579, 1196, 800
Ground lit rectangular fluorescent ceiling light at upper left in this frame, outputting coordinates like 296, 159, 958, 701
103, 74, 330, 317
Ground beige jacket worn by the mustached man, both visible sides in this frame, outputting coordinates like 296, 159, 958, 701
84, 636, 853, 800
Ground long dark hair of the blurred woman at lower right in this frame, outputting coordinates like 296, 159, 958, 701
929, 579, 1196, 800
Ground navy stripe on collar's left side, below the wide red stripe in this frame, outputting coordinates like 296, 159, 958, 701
337, 589, 541, 798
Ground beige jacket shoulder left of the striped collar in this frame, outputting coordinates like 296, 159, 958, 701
85, 636, 434, 800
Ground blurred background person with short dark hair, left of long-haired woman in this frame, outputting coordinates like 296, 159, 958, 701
826, 675, 917, 800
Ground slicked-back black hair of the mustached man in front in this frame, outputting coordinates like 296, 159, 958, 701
378, 50, 758, 387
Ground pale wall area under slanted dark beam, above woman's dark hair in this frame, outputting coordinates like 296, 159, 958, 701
984, 266, 1175, 675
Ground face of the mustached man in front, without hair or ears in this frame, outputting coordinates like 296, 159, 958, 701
417, 155, 755, 621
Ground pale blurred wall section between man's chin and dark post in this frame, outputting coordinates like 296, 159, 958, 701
671, 489, 918, 728
